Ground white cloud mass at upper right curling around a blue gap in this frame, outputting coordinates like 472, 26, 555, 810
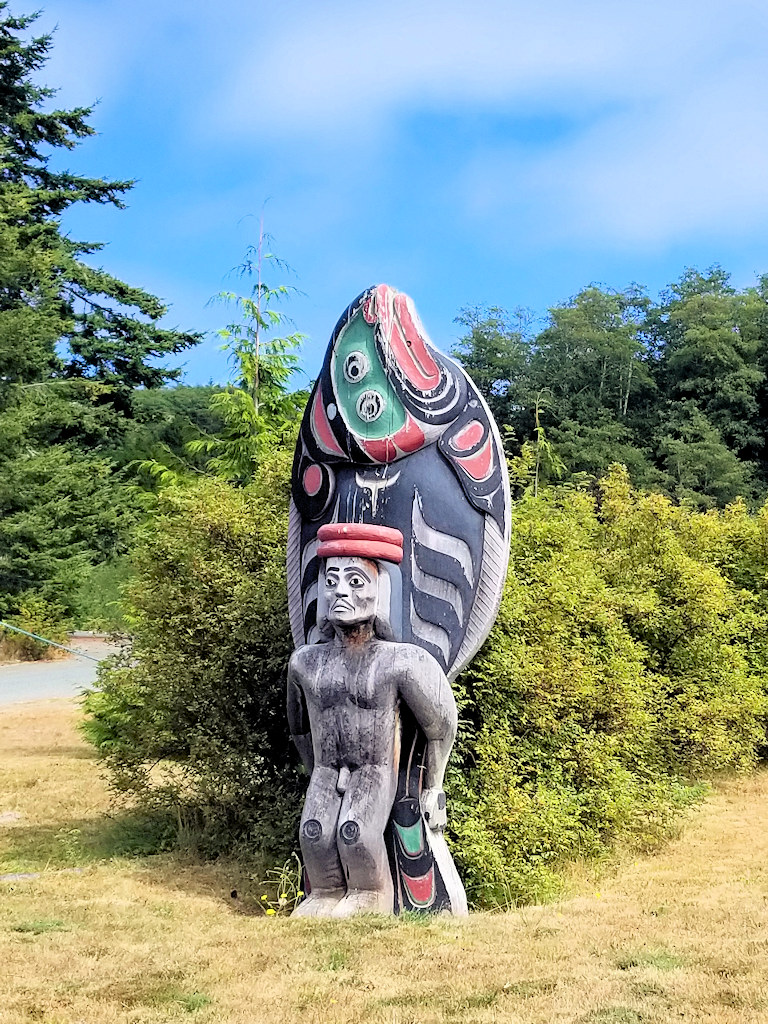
204, 0, 768, 247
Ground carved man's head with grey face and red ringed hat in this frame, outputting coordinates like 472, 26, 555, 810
310, 523, 402, 642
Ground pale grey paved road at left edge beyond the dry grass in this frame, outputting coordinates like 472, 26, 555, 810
0, 638, 121, 705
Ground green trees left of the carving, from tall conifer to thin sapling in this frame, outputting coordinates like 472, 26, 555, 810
0, 0, 305, 638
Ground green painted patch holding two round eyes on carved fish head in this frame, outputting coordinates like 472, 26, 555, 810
331, 313, 406, 440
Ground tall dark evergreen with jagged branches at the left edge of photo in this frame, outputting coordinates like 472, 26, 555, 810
0, 6, 200, 613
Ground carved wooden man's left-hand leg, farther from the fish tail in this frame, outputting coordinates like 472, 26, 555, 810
294, 767, 346, 918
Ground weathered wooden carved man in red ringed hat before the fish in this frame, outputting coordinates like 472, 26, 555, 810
288, 525, 457, 918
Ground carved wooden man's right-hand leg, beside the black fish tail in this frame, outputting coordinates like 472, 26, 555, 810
334, 765, 396, 918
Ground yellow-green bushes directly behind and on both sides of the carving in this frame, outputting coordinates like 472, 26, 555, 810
86, 464, 768, 906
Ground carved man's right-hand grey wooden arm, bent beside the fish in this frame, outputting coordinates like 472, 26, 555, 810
399, 648, 459, 828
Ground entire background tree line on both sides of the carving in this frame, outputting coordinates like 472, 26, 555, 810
0, 0, 768, 628
